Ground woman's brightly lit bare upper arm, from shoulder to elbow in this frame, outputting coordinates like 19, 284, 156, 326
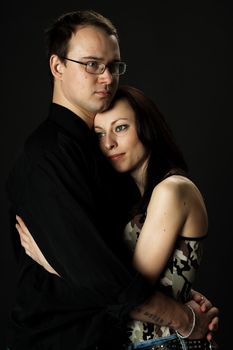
133, 178, 193, 282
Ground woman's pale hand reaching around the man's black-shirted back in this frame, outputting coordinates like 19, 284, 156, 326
15, 215, 59, 276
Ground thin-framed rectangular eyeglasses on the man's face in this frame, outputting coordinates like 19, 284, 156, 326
61, 57, 126, 75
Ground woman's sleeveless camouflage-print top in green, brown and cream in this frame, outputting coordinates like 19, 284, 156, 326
124, 214, 206, 343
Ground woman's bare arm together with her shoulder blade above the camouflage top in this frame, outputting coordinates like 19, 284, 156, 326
134, 177, 208, 283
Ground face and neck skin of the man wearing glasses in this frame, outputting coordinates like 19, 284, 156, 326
54, 26, 120, 125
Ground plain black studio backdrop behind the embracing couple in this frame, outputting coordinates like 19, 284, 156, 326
0, 0, 233, 350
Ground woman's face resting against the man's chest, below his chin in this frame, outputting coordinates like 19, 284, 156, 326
94, 99, 147, 176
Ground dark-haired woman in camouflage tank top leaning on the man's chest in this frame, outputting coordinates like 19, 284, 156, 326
17, 86, 215, 349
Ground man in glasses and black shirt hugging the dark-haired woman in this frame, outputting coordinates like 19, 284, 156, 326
8, 11, 217, 350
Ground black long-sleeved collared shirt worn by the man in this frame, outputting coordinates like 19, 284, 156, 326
7, 104, 149, 350
